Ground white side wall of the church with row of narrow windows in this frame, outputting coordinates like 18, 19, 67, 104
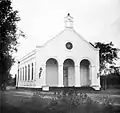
16, 53, 36, 87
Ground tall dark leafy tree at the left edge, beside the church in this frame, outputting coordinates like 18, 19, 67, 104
0, 0, 24, 90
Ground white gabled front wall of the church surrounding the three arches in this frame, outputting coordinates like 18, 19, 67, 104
36, 29, 99, 89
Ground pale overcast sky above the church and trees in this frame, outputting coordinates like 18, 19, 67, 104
10, 0, 120, 76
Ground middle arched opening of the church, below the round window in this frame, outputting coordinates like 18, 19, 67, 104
63, 59, 75, 87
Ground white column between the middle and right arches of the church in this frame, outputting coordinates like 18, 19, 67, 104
75, 65, 81, 87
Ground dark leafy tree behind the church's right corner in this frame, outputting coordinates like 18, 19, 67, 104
94, 42, 119, 88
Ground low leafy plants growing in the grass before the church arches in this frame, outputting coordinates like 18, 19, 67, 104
40, 90, 115, 113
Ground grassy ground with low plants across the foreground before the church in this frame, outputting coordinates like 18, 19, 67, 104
0, 90, 120, 113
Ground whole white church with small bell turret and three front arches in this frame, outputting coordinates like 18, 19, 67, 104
16, 14, 100, 90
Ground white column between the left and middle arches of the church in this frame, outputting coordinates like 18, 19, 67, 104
58, 65, 64, 87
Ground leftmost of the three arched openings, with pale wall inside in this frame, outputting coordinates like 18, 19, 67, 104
46, 58, 58, 86
